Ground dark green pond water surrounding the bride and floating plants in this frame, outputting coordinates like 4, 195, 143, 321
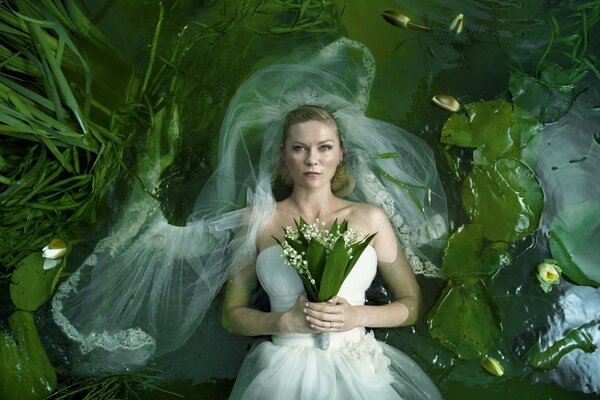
54, 0, 600, 400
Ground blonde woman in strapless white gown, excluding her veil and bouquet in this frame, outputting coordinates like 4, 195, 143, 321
223, 106, 440, 399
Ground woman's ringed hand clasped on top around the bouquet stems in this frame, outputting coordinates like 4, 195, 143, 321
304, 296, 360, 332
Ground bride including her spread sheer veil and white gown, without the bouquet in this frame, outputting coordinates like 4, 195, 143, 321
52, 38, 446, 399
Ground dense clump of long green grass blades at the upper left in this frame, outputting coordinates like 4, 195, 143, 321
0, 0, 134, 268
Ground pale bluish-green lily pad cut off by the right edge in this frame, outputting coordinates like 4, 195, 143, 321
550, 201, 600, 287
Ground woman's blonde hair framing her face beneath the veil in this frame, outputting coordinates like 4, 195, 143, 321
277, 105, 355, 197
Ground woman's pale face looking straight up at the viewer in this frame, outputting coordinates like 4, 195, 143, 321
282, 121, 344, 188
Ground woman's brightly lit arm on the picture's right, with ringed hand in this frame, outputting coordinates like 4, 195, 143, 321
307, 207, 421, 332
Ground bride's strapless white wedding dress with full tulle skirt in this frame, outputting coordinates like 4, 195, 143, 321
230, 245, 442, 400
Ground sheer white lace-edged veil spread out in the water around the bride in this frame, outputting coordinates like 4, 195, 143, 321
53, 38, 446, 373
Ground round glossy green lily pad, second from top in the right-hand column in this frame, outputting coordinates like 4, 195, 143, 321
462, 158, 544, 242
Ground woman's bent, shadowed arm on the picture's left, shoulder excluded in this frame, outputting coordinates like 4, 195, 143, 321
221, 263, 312, 336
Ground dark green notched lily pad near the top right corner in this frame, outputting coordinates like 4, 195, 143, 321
509, 62, 586, 123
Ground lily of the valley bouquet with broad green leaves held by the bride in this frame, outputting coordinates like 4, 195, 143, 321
275, 218, 376, 349
